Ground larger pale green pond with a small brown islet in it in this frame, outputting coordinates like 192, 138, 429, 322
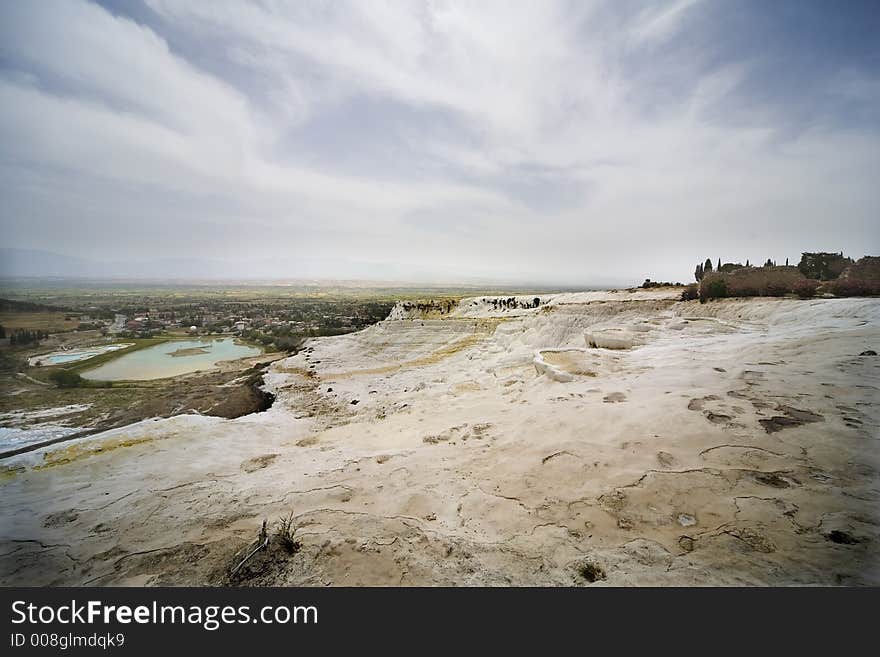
82, 338, 262, 381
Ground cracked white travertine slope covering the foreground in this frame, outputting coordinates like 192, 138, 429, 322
0, 290, 880, 586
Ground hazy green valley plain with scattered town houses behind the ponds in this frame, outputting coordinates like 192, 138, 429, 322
0, 287, 395, 351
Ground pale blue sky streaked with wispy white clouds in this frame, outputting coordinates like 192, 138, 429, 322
0, 0, 880, 286
